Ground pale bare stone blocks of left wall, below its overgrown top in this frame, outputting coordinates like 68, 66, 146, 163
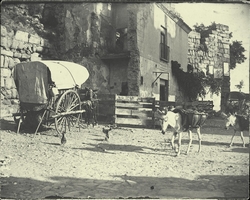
0, 25, 50, 115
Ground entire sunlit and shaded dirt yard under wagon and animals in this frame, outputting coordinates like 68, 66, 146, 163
0, 115, 249, 199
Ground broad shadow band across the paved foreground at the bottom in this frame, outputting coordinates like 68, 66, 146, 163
1, 175, 249, 199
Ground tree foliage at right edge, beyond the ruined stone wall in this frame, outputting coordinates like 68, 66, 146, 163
230, 40, 246, 69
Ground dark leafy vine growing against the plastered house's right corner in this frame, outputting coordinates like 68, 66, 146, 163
172, 62, 222, 101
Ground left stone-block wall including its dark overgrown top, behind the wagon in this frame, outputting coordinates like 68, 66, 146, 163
0, 3, 51, 117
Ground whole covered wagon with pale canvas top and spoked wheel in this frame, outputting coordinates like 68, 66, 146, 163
13, 60, 89, 134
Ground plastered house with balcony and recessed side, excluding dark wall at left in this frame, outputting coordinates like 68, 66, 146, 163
98, 3, 191, 101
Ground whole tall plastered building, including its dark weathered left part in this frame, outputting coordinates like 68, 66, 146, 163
47, 3, 191, 101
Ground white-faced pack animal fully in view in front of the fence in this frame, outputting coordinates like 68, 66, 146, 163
156, 109, 207, 156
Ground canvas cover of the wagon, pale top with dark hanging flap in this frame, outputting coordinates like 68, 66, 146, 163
13, 60, 89, 104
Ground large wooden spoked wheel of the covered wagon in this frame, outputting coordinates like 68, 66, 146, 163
55, 90, 81, 135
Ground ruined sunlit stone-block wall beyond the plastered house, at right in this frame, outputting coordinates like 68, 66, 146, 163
188, 24, 230, 109
